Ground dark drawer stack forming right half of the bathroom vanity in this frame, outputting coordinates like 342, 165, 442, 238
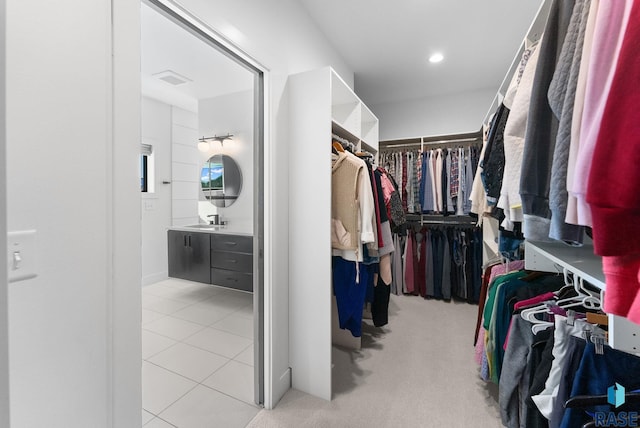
211, 233, 253, 291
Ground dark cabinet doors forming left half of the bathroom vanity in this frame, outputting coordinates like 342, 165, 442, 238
168, 230, 211, 284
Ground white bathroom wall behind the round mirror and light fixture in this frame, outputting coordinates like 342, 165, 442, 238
198, 90, 254, 233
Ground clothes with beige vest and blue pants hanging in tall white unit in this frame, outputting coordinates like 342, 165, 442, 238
331, 152, 395, 337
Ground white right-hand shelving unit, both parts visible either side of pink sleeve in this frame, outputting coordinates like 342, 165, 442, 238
525, 241, 640, 355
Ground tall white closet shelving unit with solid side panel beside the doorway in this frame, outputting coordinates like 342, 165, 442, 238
288, 67, 379, 400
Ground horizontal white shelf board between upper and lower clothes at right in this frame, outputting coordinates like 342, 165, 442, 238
525, 241, 605, 290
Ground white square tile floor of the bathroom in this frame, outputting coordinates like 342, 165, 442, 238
142, 279, 260, 428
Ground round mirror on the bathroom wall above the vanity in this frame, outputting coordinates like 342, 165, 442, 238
200, 155, 242, 207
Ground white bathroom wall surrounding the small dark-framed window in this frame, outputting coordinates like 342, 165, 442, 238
140, 97, 171, 285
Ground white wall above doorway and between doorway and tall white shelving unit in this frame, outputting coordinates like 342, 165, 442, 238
180, 0, 353, 408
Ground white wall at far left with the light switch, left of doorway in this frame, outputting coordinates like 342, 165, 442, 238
3, 0, 141, 428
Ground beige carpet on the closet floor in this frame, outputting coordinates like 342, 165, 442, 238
248, 296, 502, 428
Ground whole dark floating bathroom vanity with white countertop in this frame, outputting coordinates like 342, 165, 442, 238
167, 225, 253, 291
